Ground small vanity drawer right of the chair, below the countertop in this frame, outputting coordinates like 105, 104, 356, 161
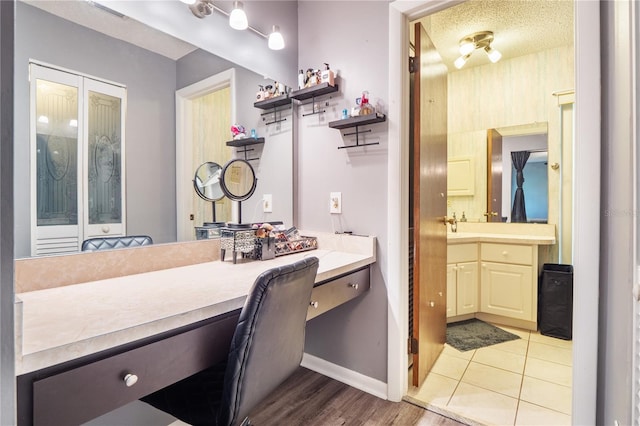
307, 266, 371, 320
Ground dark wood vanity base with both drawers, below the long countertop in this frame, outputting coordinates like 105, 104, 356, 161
17, 266, 370, 426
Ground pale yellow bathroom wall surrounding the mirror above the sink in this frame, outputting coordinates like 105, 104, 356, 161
448, 45, 574, 257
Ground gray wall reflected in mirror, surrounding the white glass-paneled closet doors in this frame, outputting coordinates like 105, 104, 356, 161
14, 2, 176, 257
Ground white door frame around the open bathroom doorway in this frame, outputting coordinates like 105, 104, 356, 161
387, 0, 601, 424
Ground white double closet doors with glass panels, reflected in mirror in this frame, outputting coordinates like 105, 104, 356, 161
30, 64, 126, 256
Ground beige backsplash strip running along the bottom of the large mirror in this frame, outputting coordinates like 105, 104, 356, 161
15, 239, 220, 294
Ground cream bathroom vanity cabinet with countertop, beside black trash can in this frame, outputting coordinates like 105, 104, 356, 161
447, 225, 555, 330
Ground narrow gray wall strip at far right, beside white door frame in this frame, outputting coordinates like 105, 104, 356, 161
600, 1, 638, 425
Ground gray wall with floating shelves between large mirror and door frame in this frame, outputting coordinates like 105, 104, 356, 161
296, 1, 398, 382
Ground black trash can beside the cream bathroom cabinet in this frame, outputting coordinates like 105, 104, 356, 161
538, 263, 573, 340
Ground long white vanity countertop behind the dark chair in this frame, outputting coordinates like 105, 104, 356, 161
16, 237, 375, 375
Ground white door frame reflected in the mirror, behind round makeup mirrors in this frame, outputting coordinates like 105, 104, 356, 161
176, 68, 237, 241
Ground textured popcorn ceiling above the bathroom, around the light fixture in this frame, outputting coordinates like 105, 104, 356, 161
411, 0, 573, 70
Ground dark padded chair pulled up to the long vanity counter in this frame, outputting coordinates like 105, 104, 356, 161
141, 257, 318, 426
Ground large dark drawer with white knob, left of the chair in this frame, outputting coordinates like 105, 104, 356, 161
30, 311, 239, 425
